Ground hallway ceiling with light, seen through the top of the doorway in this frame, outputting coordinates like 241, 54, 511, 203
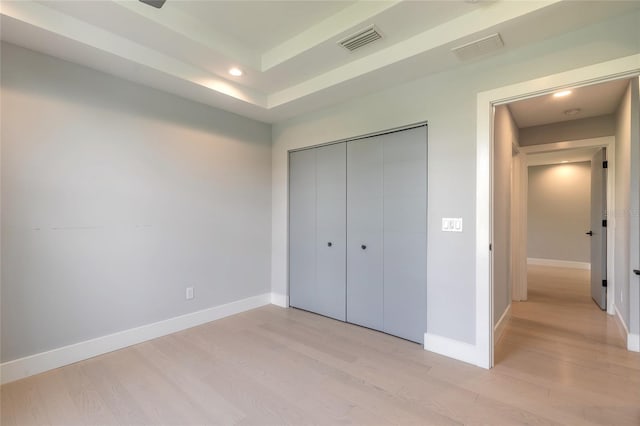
509, 79, 629, 129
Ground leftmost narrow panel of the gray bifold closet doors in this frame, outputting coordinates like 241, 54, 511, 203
289, 150, 316, 311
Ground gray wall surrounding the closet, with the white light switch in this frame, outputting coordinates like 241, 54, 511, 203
272, 9, 640, 343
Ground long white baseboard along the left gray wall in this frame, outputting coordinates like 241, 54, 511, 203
0, 293, 272, 384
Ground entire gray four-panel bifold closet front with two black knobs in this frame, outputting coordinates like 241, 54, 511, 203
289, 125, 427, 343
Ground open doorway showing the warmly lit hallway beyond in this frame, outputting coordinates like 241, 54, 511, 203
491, 78, 631, 368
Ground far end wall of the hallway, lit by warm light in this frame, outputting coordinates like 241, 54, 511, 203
527, 161, 591, 262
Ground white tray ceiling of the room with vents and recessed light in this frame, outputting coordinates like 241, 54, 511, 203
0, 0, 640, 122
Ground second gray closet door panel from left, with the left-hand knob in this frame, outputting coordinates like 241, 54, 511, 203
315, 143, 347, 321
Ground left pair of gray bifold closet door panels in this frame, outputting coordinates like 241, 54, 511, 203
289, 143, 346, 321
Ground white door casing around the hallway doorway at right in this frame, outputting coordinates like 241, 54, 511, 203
466, 55, 640, 368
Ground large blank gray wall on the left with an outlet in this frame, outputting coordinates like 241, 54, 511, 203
1, 44, 271, 361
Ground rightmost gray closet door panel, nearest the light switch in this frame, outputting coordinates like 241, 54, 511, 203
381, 127, 427, 343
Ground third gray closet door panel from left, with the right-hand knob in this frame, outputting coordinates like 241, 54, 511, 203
347, 137, 383, 330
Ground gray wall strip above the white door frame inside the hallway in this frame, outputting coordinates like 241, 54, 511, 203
520, 114, 616, 146
